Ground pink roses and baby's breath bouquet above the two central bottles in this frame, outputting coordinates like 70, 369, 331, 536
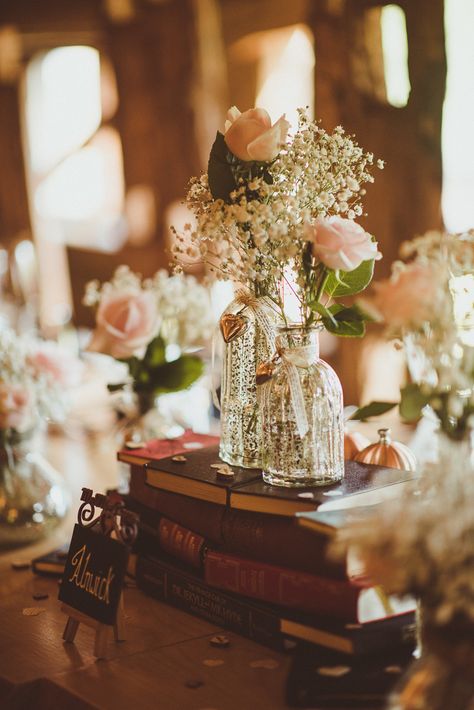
174, 107, 383, 337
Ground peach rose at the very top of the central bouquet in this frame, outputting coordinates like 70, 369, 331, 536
224, 106, 290, 162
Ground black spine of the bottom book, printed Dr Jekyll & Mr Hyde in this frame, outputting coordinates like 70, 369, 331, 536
136, 555, 284, 650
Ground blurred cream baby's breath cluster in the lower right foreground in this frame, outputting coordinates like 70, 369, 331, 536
339, 437, 474, 625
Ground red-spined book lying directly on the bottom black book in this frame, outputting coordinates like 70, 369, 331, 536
204, 550, 415, 624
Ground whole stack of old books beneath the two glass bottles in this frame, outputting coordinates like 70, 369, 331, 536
118, 432, 414, 654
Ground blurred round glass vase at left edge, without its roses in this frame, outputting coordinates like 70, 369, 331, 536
0, 433, 70, 549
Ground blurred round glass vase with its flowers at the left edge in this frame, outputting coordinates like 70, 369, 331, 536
0, 328, 82, 547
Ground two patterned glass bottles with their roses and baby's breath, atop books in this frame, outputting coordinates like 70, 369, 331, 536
175, 107, 383, 486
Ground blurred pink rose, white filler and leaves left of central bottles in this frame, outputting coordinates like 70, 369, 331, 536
84, 266, 213, 410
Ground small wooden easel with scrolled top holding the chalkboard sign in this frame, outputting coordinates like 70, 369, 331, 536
61, 488, 138, 659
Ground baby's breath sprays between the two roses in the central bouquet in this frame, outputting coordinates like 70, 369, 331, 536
174, 109, 383, 294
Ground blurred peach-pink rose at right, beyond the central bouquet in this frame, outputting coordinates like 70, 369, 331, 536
370, 263, 441, 329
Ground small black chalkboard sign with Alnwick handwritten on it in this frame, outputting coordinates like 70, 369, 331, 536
59, 525, 128, 625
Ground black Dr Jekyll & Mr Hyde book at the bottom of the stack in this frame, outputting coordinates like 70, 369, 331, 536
136, 555, 415, 655
